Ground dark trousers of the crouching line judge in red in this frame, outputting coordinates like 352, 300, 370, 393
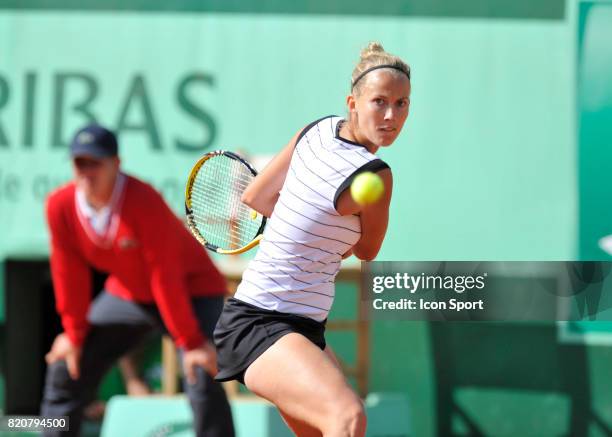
41, 292, 234, 437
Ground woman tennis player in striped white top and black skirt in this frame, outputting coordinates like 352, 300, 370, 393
215, 43, 410, 437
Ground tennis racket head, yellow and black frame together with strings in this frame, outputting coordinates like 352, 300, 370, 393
185, 150, 266, 255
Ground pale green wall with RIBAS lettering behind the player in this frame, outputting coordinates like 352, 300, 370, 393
0, 6, 577, 260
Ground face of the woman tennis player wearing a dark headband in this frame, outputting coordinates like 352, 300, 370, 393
348, 70, 410, 148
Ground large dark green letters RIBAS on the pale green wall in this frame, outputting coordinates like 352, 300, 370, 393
0, 71, 217, 153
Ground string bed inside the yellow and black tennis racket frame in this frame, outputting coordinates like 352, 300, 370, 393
191, 155, 262, 250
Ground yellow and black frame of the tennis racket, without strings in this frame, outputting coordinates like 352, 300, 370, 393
185, 150, 267, 255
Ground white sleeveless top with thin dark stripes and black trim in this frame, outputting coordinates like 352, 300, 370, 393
234, 116, 388, 322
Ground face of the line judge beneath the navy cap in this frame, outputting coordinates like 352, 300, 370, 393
72, 156, 119, 199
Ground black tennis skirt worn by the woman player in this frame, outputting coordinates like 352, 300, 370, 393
214, 297, 326, 384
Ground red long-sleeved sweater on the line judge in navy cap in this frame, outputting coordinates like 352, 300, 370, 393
47, 176, 226, 349
